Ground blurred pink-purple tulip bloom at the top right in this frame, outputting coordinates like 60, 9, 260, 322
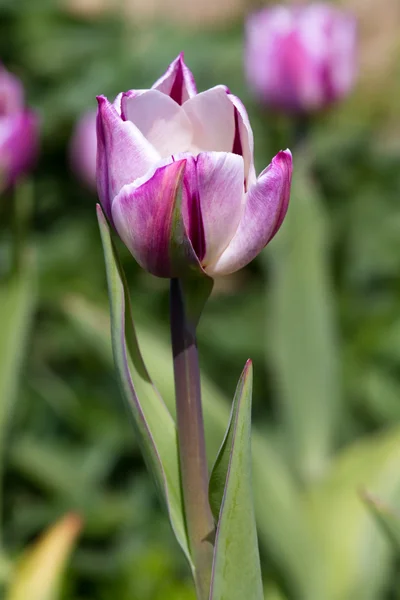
245, 3, 356, 113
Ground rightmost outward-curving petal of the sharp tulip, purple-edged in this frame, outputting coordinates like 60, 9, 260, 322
205, 150, 292, 276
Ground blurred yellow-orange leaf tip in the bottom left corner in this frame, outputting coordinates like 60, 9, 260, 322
6, 514, 82, 600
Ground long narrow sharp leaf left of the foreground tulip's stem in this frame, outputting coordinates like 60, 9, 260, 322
98, 207, 193, 570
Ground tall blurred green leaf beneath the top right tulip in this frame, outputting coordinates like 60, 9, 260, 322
265, 157, 340, 482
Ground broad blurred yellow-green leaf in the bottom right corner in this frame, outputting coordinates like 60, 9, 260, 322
308, 427, 400, 600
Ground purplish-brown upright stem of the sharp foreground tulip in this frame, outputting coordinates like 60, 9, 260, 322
171, 279, 215, 600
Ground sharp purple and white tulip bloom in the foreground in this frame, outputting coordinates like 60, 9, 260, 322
97, 54, 292, 277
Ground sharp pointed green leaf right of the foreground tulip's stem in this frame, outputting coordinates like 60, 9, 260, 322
210, 361, 263, 600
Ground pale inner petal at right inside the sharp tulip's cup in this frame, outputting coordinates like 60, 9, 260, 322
183, 85, 235, 153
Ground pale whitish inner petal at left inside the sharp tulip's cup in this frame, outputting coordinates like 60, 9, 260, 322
121, 90, 193, 157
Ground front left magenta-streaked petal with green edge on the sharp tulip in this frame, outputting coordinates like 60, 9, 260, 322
112, 159, 199, 277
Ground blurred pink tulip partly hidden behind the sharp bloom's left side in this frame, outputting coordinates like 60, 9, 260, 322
70, 111, 97, 189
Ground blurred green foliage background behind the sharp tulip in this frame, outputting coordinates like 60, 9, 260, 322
0, 0, 400, 600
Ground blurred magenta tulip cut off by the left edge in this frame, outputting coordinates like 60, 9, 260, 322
0, 65, 38, 189
